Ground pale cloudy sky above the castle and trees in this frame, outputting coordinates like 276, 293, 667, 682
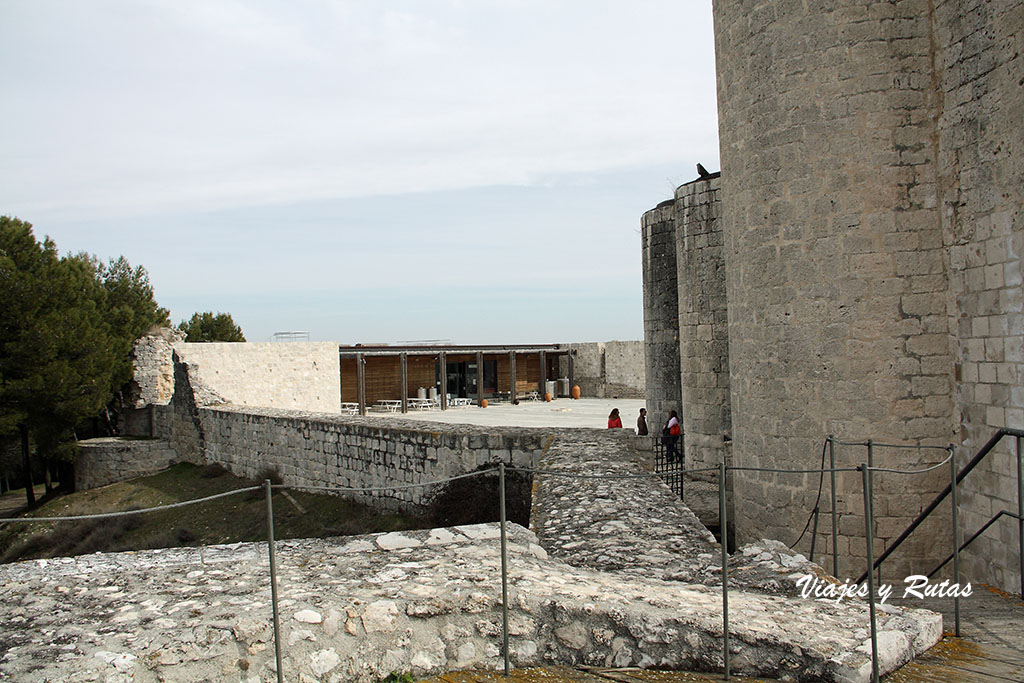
0, 0, 719, 344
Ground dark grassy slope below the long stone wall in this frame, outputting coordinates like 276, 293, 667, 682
0, 463, 432, 562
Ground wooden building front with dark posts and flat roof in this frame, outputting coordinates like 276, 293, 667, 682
338, 344, 573, 415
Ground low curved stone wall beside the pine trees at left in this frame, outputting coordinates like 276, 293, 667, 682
75, 438, 178, 490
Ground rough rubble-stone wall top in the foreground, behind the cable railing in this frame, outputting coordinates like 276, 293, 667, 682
0, 430, 941, 683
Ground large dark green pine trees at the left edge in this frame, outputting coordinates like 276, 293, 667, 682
0, 216, 167, 505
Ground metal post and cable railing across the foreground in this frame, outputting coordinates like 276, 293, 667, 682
6, 429, 1024, 683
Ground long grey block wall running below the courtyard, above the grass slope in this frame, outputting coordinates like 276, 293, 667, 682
198, 405, 548, 510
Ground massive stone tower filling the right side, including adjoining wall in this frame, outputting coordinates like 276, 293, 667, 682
643, 0, 1024, 588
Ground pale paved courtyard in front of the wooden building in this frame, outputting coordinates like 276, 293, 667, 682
380, 398, 653, 430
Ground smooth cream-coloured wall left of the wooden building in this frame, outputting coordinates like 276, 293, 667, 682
175, 342, 341, 413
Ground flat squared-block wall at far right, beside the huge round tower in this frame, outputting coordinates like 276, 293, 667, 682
935, 0, 1024, 592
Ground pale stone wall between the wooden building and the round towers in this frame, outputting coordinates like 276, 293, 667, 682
558, 341, 646, 398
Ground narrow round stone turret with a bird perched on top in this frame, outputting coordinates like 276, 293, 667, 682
676, 177, 732, 468
